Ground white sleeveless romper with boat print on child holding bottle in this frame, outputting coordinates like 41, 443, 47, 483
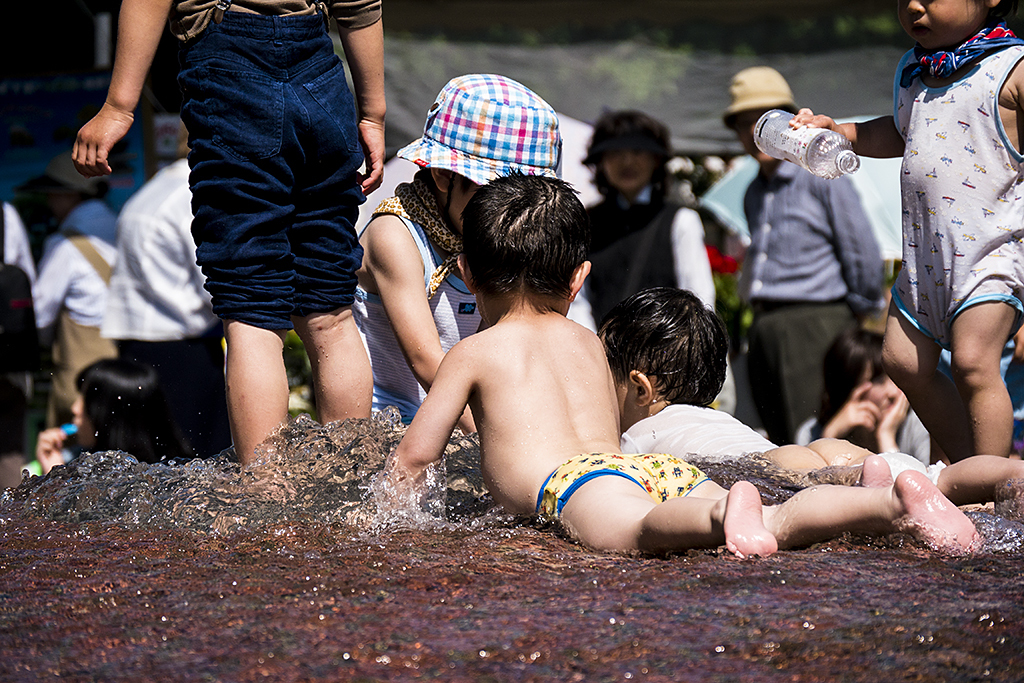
893, 46, 1024, 348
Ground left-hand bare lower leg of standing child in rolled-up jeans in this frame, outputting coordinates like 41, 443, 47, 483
224, 321, 288, 465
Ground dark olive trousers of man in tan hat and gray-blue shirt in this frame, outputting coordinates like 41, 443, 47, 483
748, 302, 857, 445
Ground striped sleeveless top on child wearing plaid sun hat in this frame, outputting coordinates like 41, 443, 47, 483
352, 216, 480, 424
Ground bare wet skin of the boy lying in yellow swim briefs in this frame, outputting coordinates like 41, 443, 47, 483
386, 176, 976, 558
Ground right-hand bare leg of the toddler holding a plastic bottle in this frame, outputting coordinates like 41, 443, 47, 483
942, 301, 1017, 462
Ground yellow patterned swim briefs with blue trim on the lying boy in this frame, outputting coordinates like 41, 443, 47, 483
537, 453, 708, 518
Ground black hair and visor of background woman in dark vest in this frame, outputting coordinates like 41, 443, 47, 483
583, 111, 672, 199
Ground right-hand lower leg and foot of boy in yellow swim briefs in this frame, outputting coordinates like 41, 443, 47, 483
764, 459, 977, 552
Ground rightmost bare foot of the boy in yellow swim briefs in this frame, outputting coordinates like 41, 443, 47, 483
893, 471, 980, 553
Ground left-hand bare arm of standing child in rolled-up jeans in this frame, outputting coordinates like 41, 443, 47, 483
72, 0, 172, 178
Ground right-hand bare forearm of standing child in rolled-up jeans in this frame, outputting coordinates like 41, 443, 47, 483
338, 19, 387, 195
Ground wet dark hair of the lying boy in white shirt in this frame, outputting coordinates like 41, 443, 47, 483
598, 287, 729, 407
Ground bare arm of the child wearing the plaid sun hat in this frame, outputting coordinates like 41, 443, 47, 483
359, 215, 476, 433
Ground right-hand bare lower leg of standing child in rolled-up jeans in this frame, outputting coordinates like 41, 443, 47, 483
294, 306, 374, 425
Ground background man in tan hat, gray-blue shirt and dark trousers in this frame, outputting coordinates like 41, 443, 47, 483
724, 67, 883, 444
